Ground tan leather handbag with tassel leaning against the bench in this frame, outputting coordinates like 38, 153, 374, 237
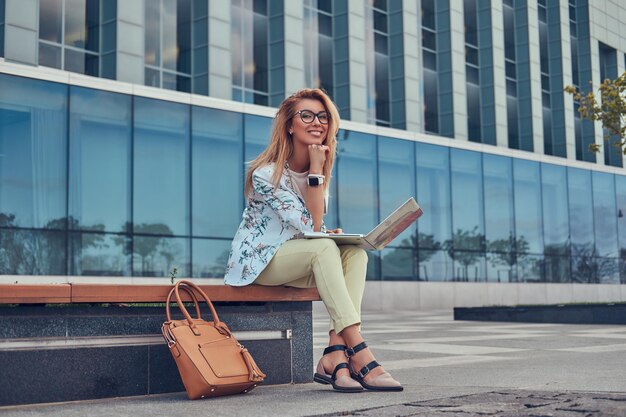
161, 281, 265, 400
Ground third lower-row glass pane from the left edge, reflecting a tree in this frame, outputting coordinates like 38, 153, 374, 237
133, 236, 190, 277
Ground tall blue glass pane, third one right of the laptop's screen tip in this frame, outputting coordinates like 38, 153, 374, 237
483, 154, 512, 252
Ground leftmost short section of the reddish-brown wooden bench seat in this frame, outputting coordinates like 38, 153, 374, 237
0, 284, 72, 304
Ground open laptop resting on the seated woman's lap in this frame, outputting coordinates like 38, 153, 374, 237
303, 197, 424, 250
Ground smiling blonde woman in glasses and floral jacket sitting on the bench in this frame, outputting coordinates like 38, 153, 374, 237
224, 89, 402, 392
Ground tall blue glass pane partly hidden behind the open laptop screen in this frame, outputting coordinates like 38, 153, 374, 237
378, 136, 417, 240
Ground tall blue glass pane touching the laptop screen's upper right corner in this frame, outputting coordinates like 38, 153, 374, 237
415, 143, 452, 249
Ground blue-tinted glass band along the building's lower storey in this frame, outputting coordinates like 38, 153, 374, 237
0, 75, 626, 283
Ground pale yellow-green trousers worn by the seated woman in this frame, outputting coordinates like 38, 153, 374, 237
254, 239, 367, 333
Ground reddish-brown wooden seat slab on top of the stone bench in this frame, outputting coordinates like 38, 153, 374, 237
0, 283, 320, 304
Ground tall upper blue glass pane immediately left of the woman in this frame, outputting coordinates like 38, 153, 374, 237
192, 107, 243, 238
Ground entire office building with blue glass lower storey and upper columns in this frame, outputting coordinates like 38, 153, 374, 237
0, 0, 626, 283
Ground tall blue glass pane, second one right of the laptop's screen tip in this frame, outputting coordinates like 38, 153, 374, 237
447, 149, 485, 250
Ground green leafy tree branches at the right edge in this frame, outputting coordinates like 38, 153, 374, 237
565, 72, 626, 154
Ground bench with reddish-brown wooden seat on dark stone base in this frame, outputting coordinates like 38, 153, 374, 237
0, 283, 320, 406
